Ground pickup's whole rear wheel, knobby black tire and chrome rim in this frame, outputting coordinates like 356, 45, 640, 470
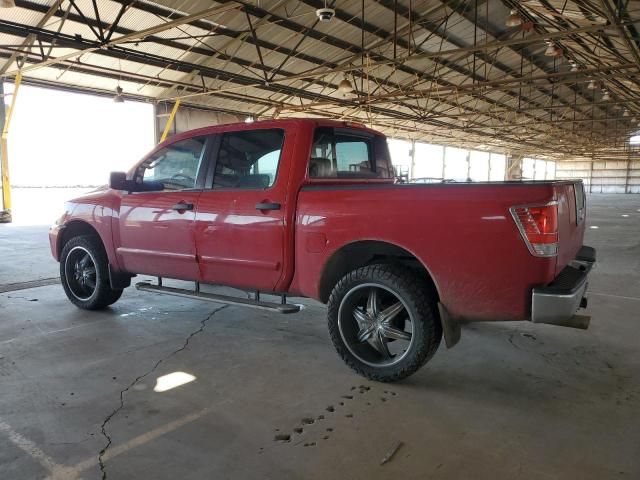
328, 264, 442, 382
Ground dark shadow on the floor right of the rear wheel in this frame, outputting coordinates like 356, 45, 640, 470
402, 323, 640, 408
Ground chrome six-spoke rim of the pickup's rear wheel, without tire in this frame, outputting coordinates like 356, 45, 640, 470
338, 283, 415, 367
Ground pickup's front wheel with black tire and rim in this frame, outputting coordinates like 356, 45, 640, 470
60, 235, 122, 310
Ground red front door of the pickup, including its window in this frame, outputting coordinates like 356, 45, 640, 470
116, 137, 208, 280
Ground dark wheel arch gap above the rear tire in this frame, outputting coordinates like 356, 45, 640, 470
318, 240, 440, 303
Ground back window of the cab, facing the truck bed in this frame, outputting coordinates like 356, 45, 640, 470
309, 127, 393, 178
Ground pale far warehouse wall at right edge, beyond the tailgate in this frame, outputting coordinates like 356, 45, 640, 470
556, 158, 640, 193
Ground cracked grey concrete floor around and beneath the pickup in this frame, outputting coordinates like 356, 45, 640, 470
0, 195, 640, 480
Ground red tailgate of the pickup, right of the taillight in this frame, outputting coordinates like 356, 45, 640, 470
553, 180, 587, 274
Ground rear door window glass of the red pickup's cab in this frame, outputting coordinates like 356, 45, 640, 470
213, 129, 284, 190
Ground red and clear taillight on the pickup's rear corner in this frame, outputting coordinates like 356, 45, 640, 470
509, 202, 558, 257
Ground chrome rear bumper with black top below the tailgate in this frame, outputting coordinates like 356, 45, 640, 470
531, 246, 596, 328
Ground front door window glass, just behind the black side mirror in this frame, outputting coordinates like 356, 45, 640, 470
136, 137, 205, 190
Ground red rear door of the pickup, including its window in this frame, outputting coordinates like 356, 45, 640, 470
196, 129, 288, 291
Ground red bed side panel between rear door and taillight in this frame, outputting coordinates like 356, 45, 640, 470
291, 184, 556, 320
